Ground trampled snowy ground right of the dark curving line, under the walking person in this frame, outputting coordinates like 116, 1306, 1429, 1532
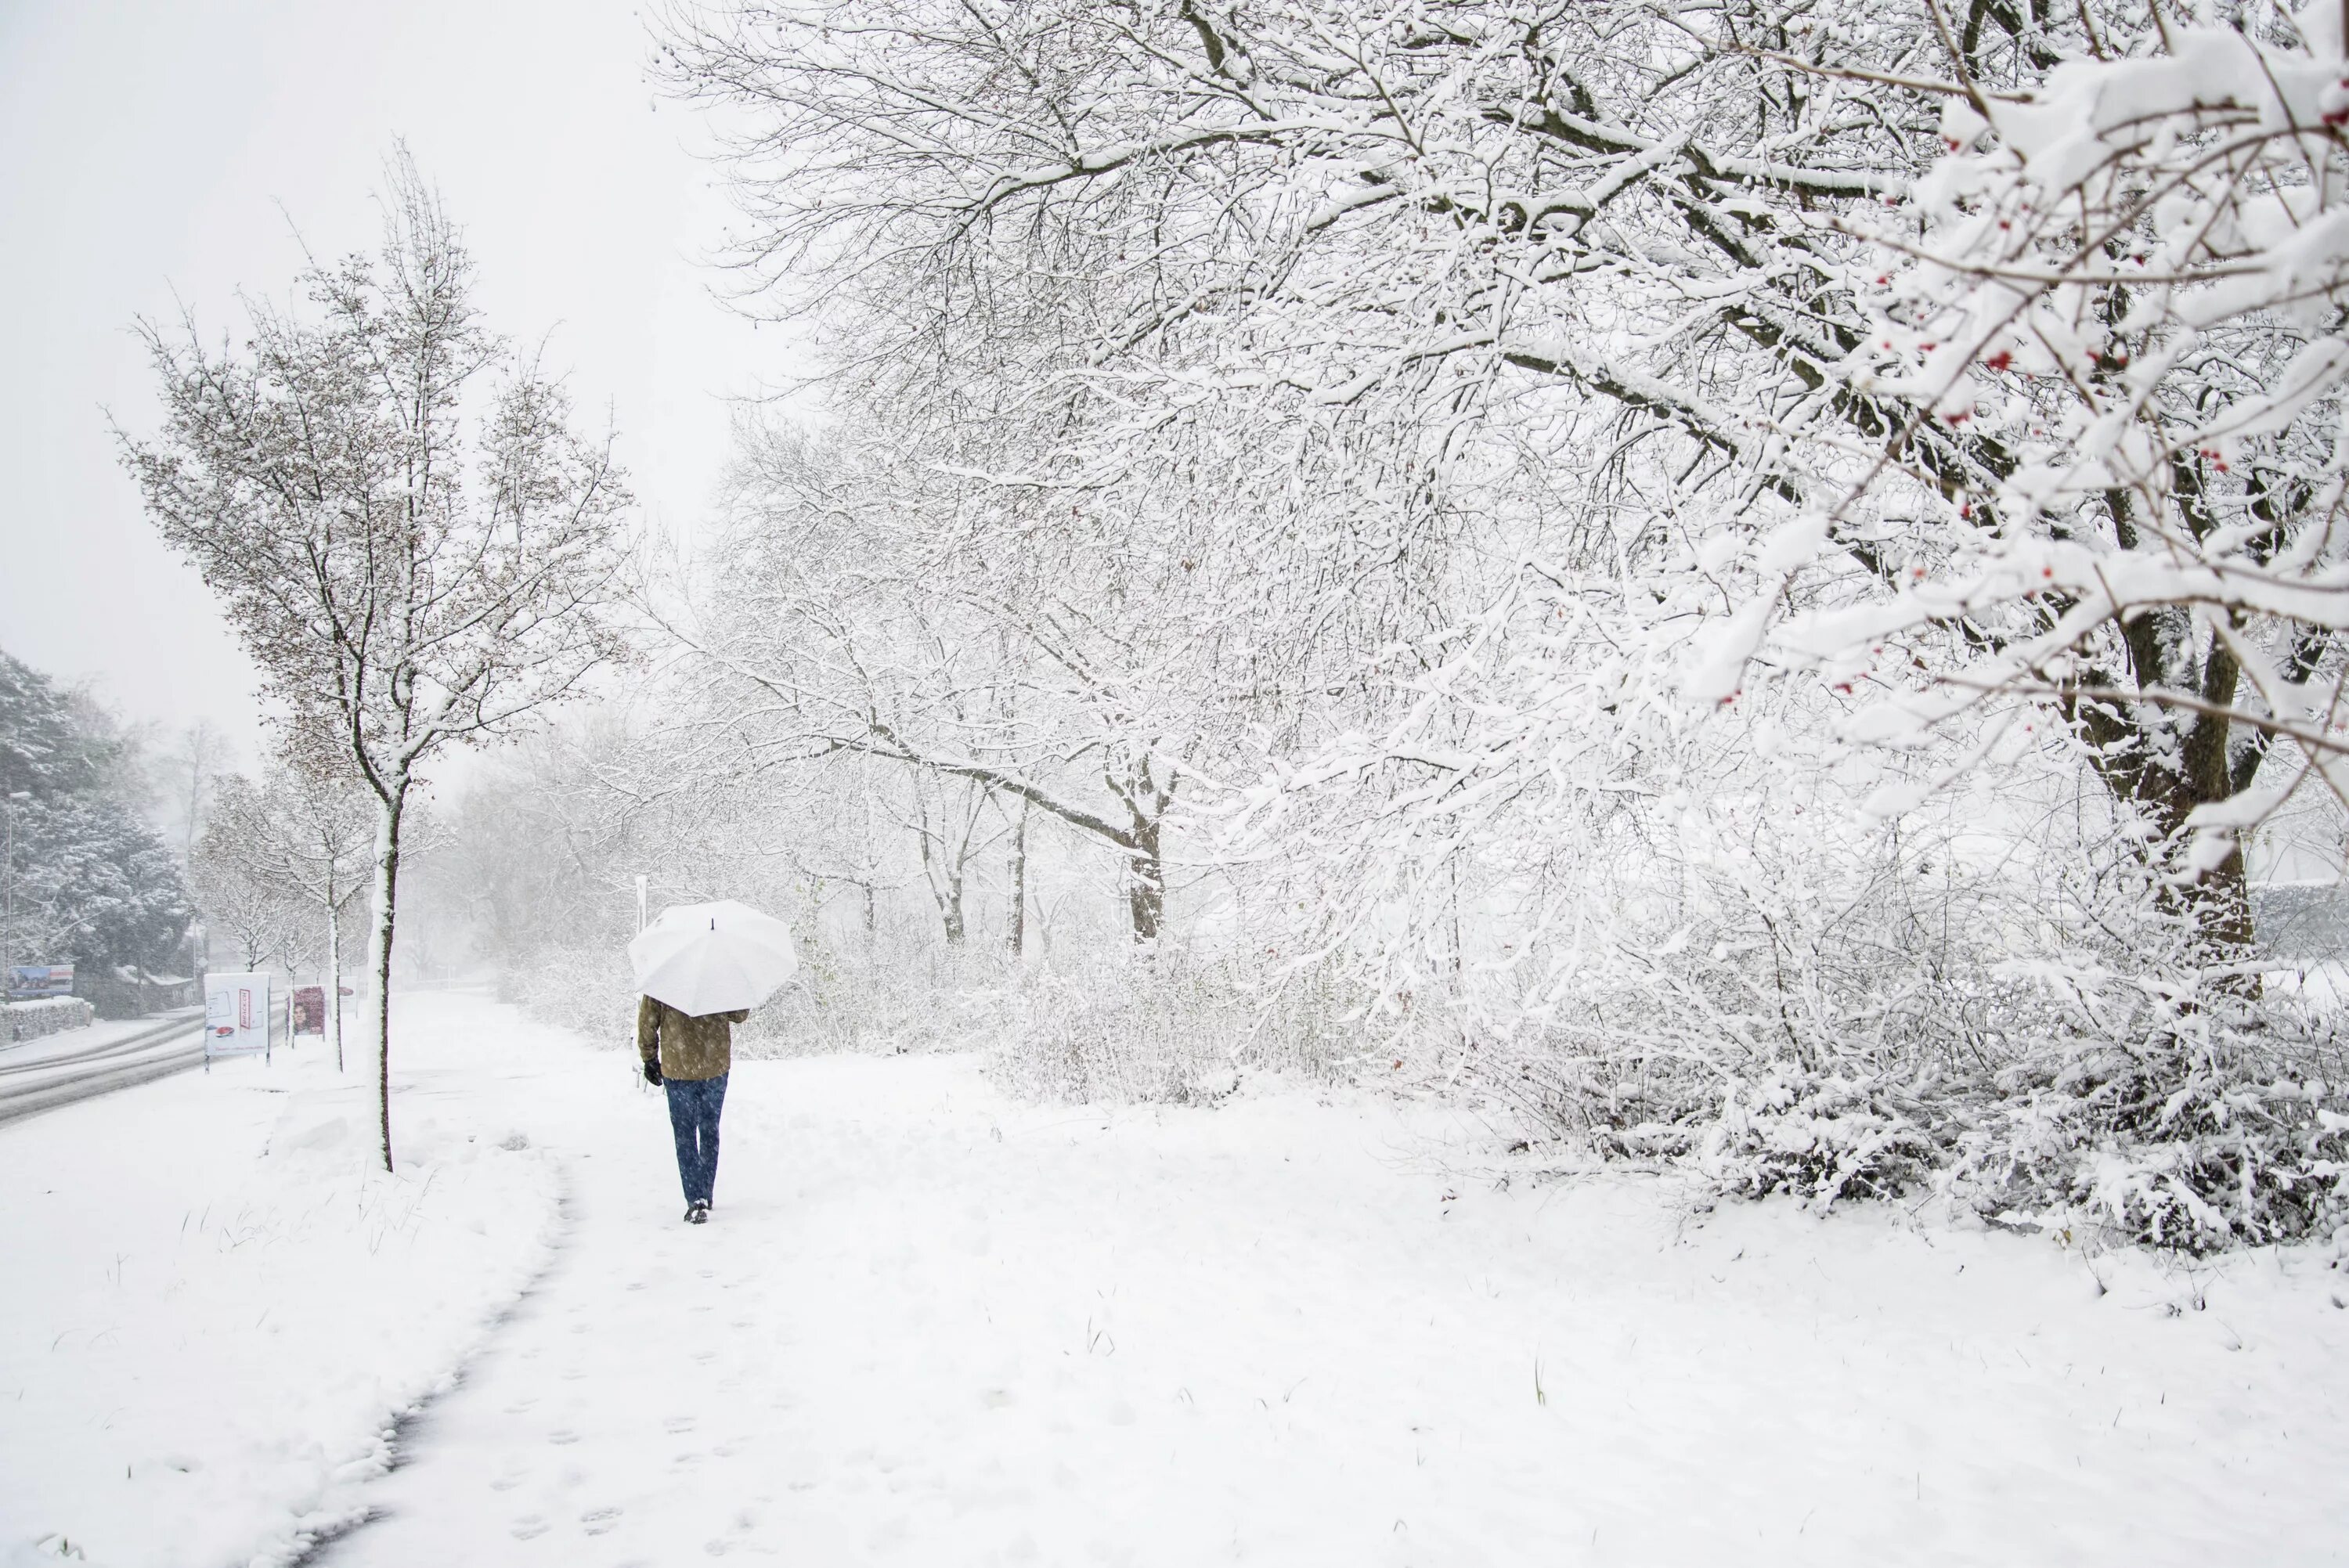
298, 1000, 2349, 1568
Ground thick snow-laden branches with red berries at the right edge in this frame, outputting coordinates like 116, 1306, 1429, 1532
1757, 5, 2349, 939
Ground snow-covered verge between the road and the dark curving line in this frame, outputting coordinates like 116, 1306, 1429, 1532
0, 1000, 559, 1568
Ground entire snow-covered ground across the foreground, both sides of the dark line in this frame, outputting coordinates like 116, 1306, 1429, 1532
0, 997, 2349, 1568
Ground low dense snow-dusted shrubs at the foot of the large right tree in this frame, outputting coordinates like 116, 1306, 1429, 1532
1470, 802, 2349, 1251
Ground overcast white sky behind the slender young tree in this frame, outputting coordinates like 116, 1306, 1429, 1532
0, 0, 782, 756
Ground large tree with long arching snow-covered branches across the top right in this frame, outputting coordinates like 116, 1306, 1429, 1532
667, 0, 2340, 967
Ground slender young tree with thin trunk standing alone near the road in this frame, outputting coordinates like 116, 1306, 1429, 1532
122, 155, 630, 1164
